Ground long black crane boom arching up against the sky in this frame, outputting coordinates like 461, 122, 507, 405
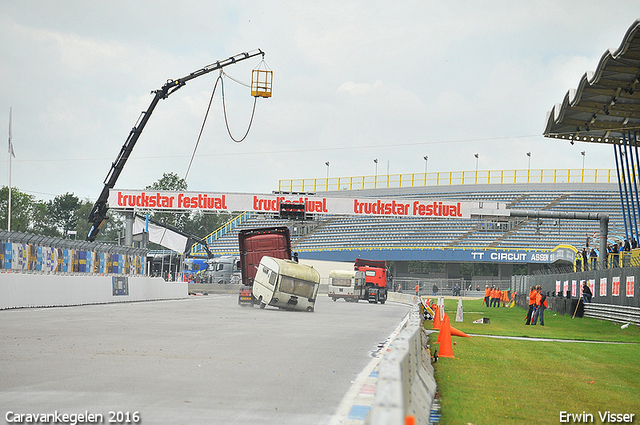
87, 49, 264, 241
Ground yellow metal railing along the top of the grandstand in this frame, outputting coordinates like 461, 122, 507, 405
278, 169, 618, 192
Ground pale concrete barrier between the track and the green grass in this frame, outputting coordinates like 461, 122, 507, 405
365, 293, 436, 425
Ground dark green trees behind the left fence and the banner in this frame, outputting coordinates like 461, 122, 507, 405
0, 173, 231, 245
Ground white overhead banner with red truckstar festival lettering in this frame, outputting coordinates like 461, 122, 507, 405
109, 189, 509, 219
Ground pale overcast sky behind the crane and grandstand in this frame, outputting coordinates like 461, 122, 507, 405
0, 0, 640, 201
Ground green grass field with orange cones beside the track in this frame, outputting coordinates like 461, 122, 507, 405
425, 300, 640, 425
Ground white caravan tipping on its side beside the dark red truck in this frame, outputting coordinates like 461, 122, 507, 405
253, 256, 320, 311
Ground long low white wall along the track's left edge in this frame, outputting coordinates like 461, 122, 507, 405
0, 273, 188, 310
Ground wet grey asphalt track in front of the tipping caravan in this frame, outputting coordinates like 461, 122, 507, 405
0, 294, 409, 425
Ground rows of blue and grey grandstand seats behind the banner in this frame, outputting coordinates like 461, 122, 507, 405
199, 183, 624, 256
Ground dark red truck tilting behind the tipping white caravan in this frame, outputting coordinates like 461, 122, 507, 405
238, 226, 291, 306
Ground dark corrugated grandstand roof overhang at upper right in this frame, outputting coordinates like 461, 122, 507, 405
543, 19, 640, 144
